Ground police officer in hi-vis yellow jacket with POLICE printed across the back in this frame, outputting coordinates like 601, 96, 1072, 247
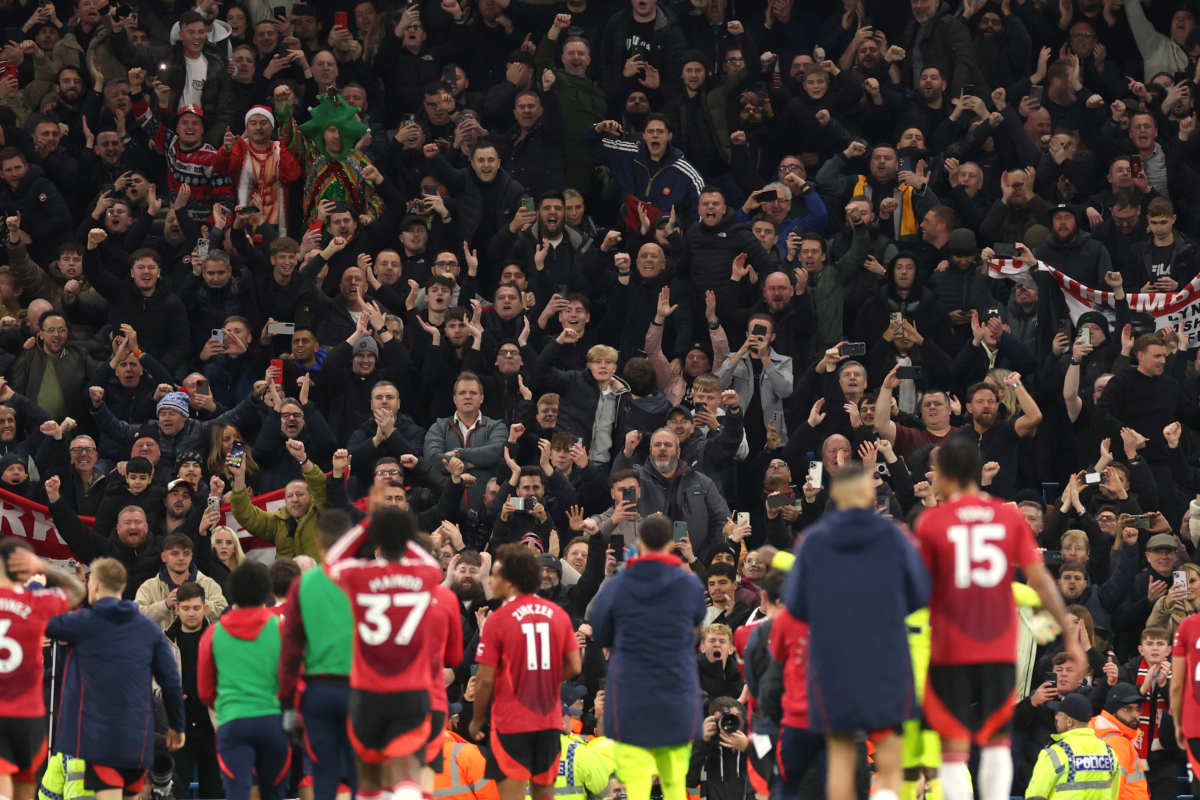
1025, 694, 1121, 800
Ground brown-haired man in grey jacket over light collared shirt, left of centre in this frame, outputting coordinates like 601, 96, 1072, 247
425, 372, 509, 507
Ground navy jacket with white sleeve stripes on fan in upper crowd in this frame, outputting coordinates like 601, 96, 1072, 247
583, 126, 704, 225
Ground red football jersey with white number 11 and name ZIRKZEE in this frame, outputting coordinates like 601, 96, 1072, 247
475, 595, 580, 733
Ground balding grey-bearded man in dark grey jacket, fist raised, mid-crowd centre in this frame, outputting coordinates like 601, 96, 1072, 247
612, 431, 729, 563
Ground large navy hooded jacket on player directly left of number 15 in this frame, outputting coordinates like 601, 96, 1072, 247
784, 509, 930, 733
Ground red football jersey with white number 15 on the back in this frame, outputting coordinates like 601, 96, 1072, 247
914, 494, 1043, 667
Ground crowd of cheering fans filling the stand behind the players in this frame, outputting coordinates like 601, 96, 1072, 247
0, 0, 1200, 800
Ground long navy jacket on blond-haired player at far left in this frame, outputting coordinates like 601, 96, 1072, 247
46, 597, 187, 769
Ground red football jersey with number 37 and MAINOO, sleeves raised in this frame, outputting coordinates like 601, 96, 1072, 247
324, 525, 442, 692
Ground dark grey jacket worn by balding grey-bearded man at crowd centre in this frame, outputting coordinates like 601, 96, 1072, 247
612, 450, 730, 564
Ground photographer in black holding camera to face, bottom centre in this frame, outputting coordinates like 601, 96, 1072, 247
688, 697, 750, 800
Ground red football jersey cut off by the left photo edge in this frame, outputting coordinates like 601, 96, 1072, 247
0, 589, 71, 717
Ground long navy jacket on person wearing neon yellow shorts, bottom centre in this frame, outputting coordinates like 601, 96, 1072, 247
588, 553, 707, 747
